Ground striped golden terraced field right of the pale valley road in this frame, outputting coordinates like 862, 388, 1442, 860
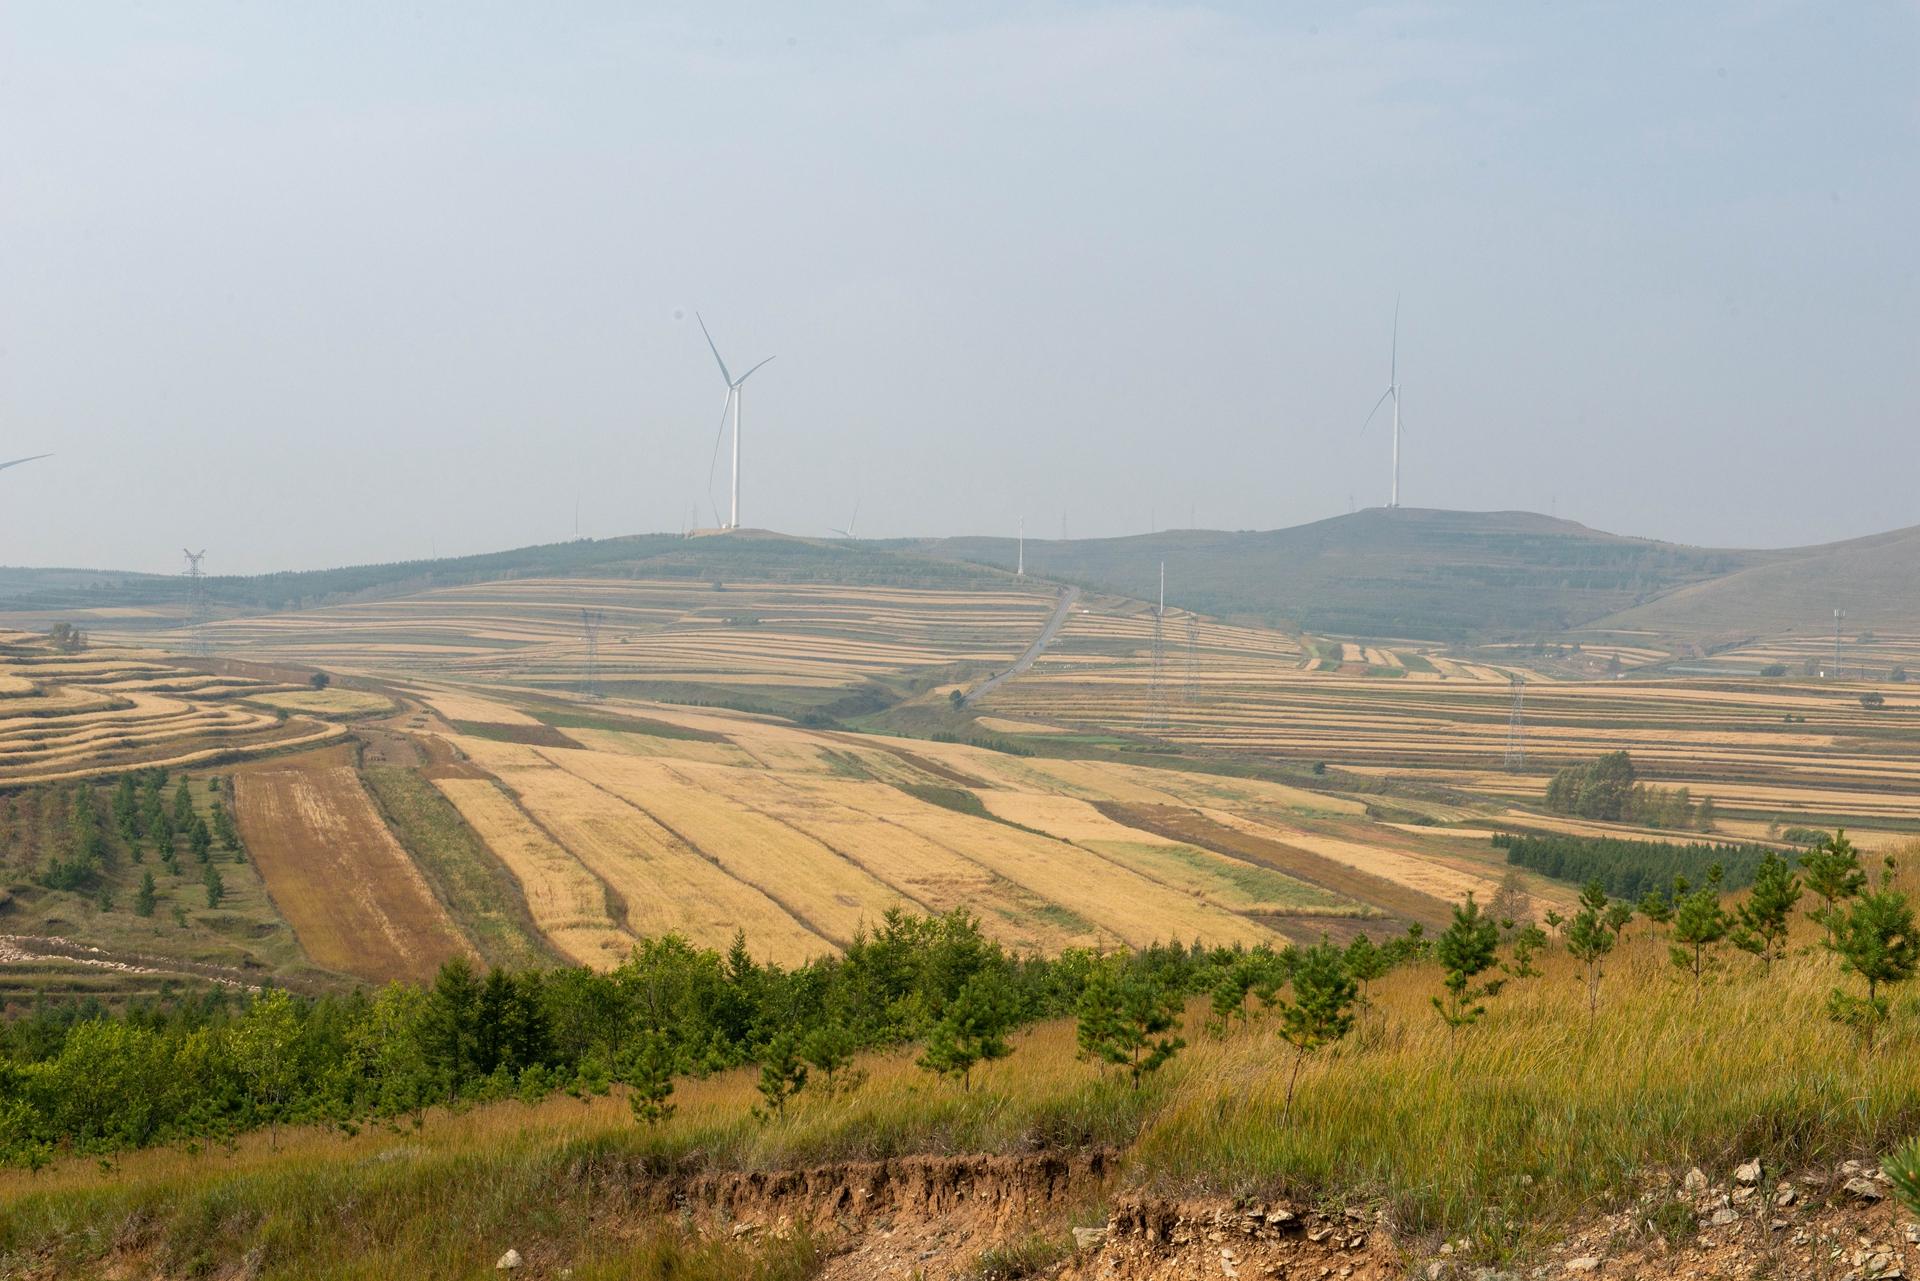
985, 655, 1920, 824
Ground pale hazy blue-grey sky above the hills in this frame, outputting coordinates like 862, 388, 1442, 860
0, 0, 1920, 572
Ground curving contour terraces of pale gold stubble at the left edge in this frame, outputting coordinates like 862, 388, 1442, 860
0, 632, 344, 787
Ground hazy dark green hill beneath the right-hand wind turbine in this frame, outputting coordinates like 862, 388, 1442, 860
889, 507, 1758, 640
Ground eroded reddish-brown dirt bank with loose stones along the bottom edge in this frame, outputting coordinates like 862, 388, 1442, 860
655, 1152, 1920, 1281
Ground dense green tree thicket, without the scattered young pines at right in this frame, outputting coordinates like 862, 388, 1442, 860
0, 912, 1428, 1164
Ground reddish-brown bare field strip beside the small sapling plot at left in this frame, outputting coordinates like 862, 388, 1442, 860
234, 762, 472, 983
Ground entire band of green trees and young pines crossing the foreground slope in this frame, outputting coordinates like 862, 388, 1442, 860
0, 834, 1920, 1168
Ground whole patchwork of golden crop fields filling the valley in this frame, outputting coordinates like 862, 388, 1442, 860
0, 580, 1920, 978
